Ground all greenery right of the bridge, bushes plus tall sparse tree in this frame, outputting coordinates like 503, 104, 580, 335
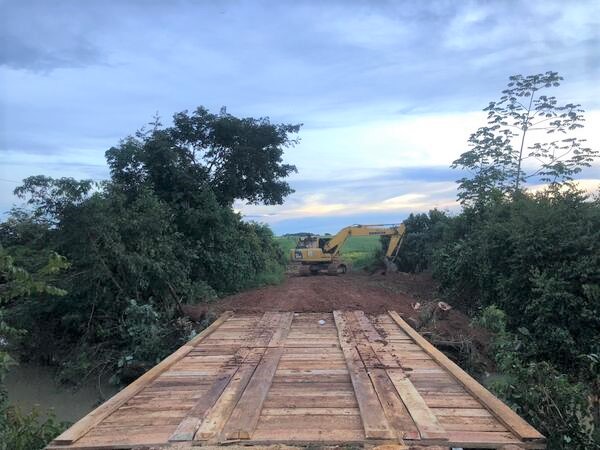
400, 72, 600, 444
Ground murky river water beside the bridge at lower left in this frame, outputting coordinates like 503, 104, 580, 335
6, 364, 118, 422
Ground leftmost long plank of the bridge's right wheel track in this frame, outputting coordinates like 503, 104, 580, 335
333, 311, 397, 439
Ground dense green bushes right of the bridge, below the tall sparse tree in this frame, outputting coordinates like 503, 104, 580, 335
400, 185, 600, 449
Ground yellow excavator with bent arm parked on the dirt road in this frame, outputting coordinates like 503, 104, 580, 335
290, 224, 406, 275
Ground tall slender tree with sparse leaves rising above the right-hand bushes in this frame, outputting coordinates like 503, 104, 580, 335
452, 72, 598, 204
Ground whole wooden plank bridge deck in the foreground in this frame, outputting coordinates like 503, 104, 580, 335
49, 311, 544, 450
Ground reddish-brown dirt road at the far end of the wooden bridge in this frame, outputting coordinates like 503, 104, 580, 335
185, 273, 489, 365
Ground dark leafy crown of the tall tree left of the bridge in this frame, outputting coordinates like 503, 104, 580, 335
106, 107, 301, 206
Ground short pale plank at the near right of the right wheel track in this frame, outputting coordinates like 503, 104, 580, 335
387, 369, 448, 440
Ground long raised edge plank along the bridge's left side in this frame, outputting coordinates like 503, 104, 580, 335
52, 311, 233, 445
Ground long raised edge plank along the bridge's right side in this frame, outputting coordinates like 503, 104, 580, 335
388, 311, 545, 441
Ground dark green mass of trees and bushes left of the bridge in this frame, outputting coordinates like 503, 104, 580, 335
0, 108, 299, 382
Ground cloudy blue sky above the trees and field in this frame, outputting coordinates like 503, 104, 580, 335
0, 0, 600, 234
